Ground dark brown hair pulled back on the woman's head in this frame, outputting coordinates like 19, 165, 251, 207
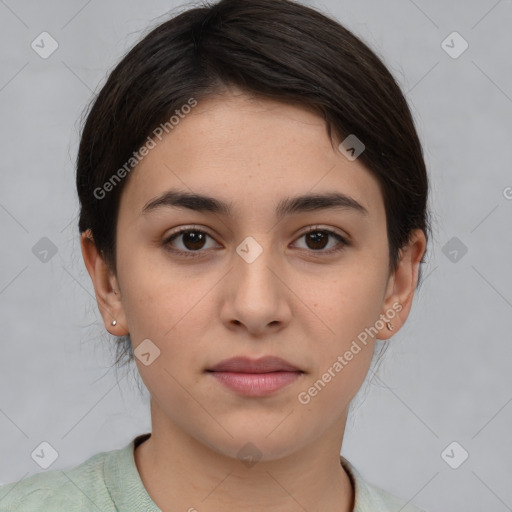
76, 0, 430, 368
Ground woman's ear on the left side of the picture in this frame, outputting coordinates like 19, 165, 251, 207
80, 229, 129, 336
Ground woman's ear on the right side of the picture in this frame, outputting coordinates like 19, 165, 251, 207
377, 229, 427, 340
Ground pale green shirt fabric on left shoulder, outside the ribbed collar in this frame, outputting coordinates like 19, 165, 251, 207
0, 452, 115, 512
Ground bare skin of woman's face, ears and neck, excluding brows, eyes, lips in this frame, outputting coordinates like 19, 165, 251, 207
81, 89, 426, 512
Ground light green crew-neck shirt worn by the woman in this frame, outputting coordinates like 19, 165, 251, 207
0, 433, 422, 512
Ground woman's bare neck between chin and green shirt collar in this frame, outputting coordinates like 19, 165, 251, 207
134, 402, 354, 512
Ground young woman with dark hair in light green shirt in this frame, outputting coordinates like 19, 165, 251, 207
0, 0, 430, 512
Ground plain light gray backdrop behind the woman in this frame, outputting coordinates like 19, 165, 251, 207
0, 0, 512, 512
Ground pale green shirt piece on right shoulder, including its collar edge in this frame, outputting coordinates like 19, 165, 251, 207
341, 457, 425, 512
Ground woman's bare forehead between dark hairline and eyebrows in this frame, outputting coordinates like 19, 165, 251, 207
116, 92, 383, 222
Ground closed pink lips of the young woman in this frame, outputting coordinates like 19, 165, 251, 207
206, 356, 305, 397
